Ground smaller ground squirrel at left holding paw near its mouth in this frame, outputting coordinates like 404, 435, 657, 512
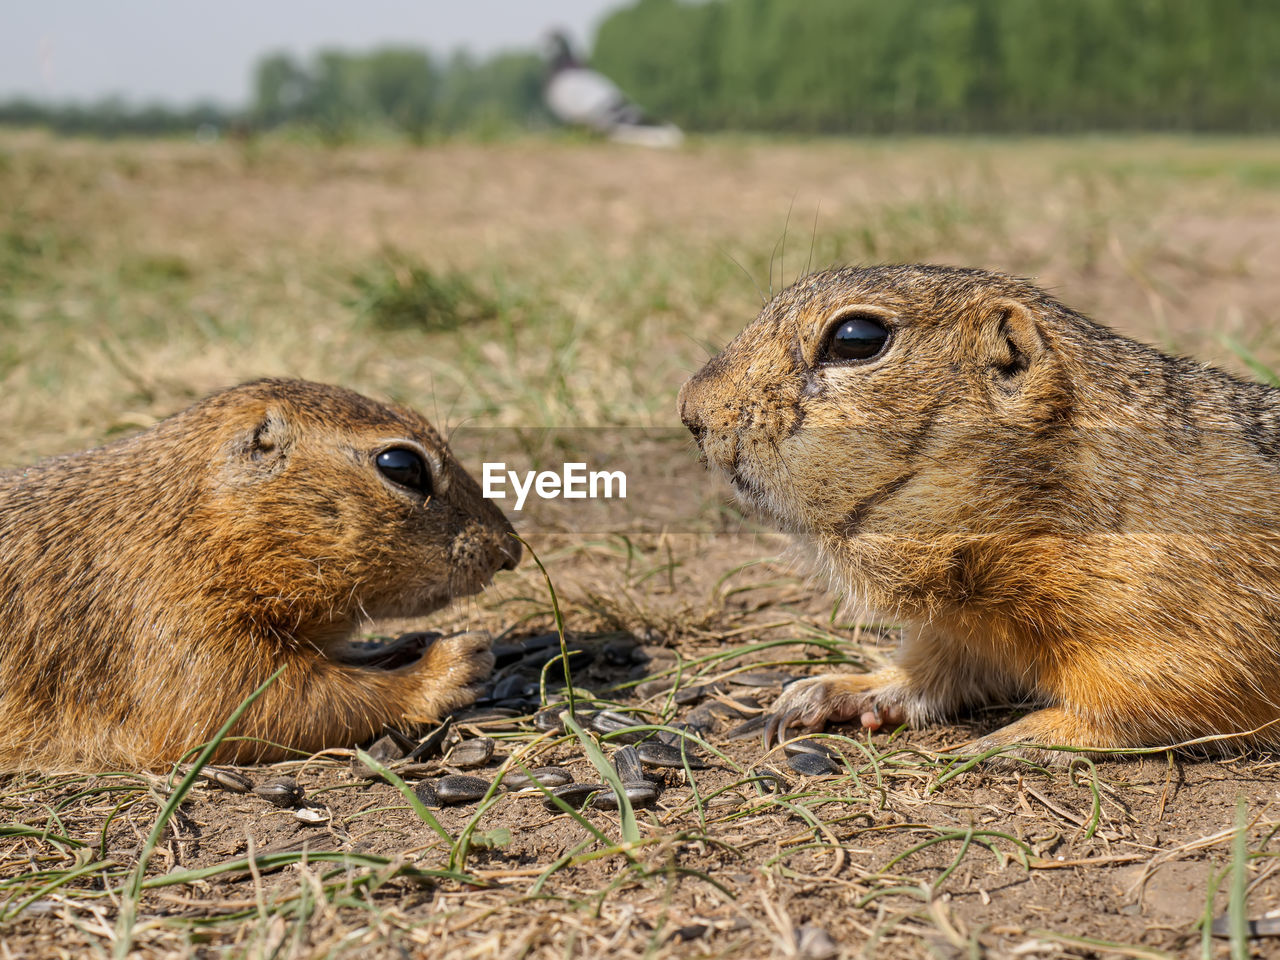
0, 380, 520, 769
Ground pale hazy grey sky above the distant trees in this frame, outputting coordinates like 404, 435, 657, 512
0, 0, 625, 104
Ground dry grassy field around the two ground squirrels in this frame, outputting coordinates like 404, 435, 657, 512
0, 133, 1280, 960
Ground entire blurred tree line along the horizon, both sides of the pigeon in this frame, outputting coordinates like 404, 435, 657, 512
0, 0, 1280, 141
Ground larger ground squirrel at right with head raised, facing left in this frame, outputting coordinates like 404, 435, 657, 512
680, 266, 1280, 749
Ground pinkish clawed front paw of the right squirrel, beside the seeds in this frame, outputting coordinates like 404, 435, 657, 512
764, 671, 906, 749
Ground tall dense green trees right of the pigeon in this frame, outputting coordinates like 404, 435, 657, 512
594, 0, 1280, 133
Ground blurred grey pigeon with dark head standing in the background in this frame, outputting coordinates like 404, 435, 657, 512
543, 32, 684, 147
